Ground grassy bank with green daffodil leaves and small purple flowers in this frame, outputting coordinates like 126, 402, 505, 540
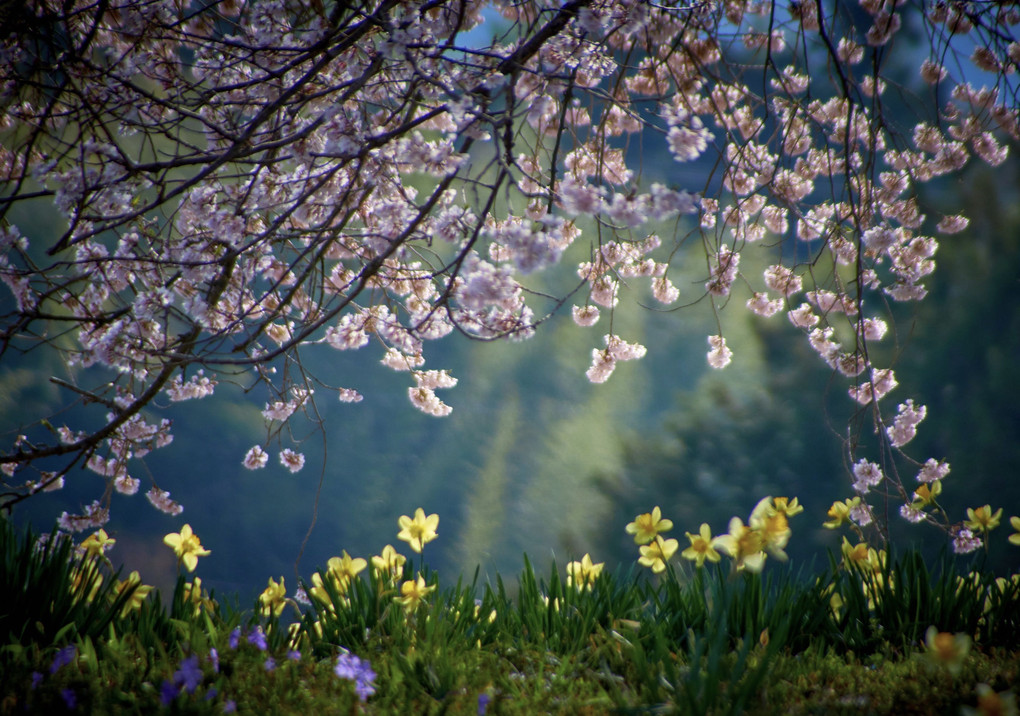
0, 523, 1020, 714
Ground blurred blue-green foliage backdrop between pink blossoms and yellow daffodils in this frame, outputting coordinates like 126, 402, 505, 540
7, 149, 1020, 594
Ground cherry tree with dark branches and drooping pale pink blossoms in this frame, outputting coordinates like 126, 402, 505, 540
0, 0, 1020, 551
